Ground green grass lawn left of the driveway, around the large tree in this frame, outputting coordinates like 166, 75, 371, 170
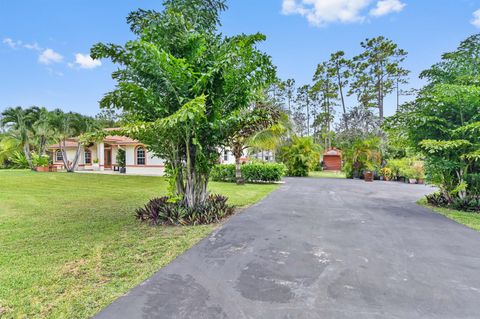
0, 170, 277, 318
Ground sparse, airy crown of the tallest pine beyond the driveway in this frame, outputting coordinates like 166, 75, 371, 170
350, 36, 409, 121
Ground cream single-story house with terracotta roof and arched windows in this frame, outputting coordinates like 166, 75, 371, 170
49, 129, 165, 175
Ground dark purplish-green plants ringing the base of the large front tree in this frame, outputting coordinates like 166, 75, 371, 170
135, 195, 234, 226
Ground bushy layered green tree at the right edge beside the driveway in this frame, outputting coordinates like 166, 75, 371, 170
386, 35, 480, 210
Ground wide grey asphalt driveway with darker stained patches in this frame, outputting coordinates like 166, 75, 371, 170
97, 179, 480, 319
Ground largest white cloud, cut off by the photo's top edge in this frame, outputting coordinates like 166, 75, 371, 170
282, 0, 371, 26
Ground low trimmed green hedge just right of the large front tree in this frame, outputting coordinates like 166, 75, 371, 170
210, 163, 286, 183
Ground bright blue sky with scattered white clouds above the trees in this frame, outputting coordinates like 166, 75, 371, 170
0, 0, 480, 119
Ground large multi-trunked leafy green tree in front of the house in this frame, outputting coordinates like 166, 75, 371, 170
91, 0, 276, 209
